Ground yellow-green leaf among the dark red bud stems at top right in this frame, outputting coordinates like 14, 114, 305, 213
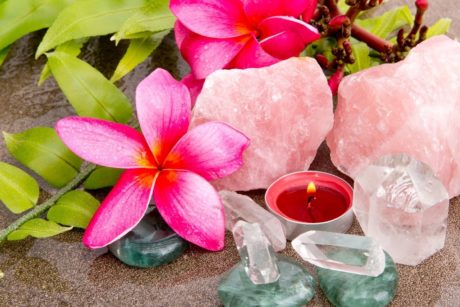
355, 6, 414, 39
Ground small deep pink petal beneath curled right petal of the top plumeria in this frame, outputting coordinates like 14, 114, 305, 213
260, 31, 305, 59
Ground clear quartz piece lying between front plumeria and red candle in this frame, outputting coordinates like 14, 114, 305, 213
219, 191, 286, 252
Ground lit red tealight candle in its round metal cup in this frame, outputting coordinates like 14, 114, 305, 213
265, 171, 353, 240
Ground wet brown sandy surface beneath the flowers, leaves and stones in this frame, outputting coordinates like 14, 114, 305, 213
0, 0, 460, 307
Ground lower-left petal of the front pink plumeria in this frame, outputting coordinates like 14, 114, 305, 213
83, 169, 157, 249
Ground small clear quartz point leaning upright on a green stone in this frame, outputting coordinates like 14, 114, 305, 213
233, 221, 280, 285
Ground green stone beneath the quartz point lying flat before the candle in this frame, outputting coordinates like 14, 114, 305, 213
317, 253, 398, 307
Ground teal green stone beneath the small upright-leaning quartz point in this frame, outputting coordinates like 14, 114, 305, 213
219, 256, 315, 307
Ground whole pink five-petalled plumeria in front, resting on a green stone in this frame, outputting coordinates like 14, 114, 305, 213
56, 69, 249, 251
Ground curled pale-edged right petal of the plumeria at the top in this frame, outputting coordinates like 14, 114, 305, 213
259, 16, 321, 45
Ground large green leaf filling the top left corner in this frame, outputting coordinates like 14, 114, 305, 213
0, 0, 75, 49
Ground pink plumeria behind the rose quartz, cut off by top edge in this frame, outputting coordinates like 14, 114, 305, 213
170, 0, 320, 80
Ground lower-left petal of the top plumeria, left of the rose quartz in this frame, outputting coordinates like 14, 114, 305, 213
181, 32, 251, 79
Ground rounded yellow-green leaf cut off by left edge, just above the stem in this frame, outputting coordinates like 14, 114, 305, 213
0, 162, 40, 214
